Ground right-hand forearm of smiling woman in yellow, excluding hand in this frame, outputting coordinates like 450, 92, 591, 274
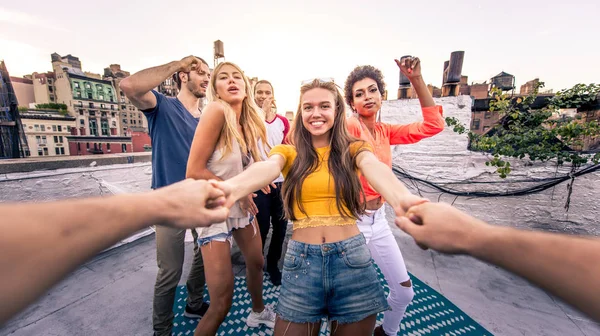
361, 159, 410, 208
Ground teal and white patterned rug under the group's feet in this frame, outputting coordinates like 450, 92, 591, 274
173, 269, 492, 336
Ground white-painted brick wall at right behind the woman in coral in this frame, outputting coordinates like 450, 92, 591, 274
382, 96, 600, 235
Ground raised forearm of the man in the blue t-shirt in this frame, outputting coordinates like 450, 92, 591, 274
121, 61, 181, 97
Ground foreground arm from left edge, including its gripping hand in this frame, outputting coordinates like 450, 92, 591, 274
0, 180, 229, 325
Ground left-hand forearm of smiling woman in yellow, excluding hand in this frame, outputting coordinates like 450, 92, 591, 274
227, 160, 281, 200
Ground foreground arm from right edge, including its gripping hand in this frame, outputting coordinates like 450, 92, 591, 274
396, 203, 600, 321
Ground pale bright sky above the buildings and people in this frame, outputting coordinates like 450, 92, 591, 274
0, 0, 600, 113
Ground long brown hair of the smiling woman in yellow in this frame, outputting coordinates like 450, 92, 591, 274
281, 79, 367, 220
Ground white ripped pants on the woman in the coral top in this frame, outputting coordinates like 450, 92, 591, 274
357, 205, 414, 335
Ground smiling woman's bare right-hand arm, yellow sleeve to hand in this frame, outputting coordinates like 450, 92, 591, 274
356, 151, 427, 215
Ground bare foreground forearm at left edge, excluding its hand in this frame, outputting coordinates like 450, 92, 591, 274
0, 196, 161, 324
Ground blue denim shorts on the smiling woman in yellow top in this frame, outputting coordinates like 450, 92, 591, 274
275, 233, 389, 323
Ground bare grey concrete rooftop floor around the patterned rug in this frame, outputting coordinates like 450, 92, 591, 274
0, 207, 600, 336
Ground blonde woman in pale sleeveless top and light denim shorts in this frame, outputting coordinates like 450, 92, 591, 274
187, 62, 275, 336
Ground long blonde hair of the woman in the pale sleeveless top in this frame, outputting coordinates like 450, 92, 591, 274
206, 62, 270, 161
